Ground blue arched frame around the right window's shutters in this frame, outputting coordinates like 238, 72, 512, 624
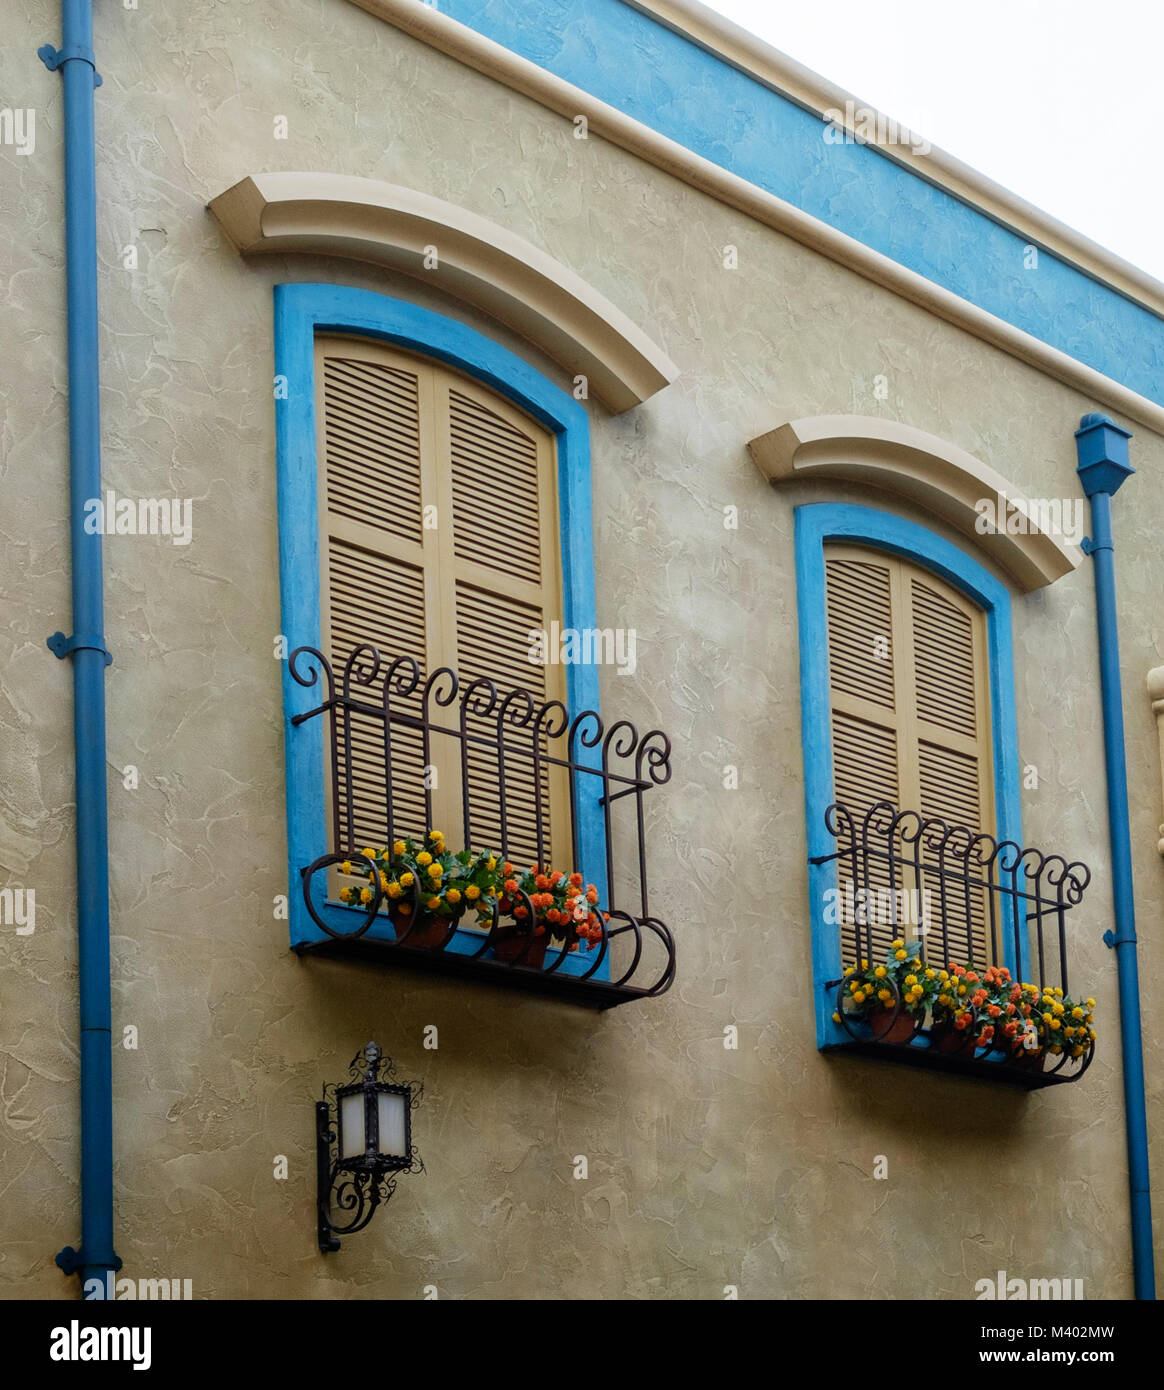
795, 503, 1022, 1047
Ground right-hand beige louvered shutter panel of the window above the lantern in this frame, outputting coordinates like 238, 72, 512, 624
437, 378, 569, 866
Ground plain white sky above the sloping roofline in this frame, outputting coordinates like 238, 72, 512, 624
704, 0, 1164, 281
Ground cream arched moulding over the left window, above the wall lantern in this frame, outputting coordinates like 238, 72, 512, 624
210, 174, 679, 413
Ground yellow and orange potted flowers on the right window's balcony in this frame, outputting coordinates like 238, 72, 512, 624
833, 938, 1096, 1065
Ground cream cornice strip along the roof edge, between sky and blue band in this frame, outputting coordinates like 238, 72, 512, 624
623, 0, 1164, 316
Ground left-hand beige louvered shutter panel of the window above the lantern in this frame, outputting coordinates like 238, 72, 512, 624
316, 339, 437, 849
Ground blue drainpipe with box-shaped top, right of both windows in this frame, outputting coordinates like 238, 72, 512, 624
1075, 414, 1156, 1298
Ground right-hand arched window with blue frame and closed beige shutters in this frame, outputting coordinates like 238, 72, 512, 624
795, 503, 1025, 1047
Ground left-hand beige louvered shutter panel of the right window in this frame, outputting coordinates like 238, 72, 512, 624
825, 548, 903, 960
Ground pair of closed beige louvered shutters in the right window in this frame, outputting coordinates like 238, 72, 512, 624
825, 545, 993, 965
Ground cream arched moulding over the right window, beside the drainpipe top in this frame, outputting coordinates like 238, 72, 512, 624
748, 416, 1083, 591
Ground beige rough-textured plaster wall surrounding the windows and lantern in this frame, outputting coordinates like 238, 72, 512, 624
0, 0, 1164, 1298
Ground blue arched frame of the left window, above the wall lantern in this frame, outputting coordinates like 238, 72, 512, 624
268, 284, 609, 979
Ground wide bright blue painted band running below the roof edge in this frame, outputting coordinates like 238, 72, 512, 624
441, 0, 1164, 404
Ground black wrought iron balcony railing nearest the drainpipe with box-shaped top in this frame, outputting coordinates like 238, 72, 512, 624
811, 802, 1094, 1088
